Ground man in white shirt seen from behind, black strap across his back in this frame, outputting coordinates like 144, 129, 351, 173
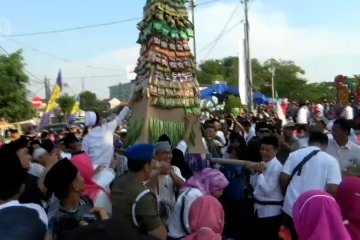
280, 132, 341, 239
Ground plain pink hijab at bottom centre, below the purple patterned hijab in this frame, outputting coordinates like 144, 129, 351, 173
183, 196, 224, 240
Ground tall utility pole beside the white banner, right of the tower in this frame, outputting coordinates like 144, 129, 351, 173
244, 0, 253, 111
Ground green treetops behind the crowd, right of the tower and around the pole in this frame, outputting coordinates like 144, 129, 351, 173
197, 57, 336, 101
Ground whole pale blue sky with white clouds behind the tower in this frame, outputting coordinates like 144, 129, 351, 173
0, 0, 360, 99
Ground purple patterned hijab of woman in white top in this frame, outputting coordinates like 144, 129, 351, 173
186, 168, 229, 195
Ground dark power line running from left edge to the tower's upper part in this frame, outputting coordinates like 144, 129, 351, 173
0, 17, 141, 38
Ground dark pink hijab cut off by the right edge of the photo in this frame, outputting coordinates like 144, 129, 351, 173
336, 177, 360, 240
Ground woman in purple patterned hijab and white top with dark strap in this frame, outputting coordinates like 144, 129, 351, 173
167, 168, 229, 240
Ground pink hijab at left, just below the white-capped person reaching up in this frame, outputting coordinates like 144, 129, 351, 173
71, 153, 108, 204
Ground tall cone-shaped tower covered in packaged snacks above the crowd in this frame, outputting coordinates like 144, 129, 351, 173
128, 0, 206, 154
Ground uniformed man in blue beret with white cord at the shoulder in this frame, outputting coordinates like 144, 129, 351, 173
112, 144, 167, 240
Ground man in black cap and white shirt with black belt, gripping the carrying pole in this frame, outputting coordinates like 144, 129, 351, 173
250, 137, 283, 240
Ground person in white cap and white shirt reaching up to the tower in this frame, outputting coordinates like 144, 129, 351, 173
81, 101, 132, 168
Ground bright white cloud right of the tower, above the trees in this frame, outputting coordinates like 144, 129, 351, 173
197, 2, 360, 81
